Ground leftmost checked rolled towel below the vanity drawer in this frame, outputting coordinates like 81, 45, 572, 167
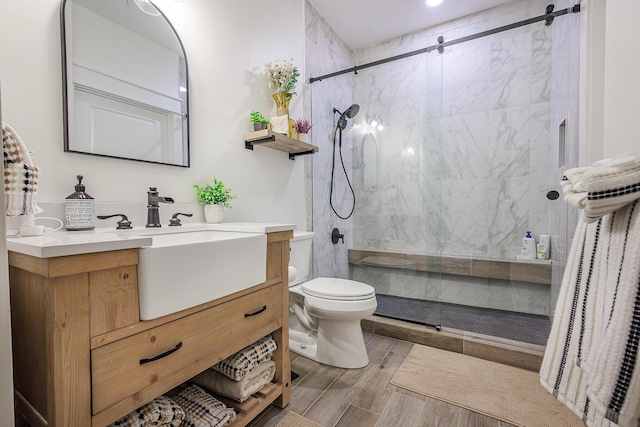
109, 396, 185, 427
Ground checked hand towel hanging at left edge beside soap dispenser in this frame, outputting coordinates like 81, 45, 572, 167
2, 123, 42, 217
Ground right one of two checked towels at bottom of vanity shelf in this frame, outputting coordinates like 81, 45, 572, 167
173, 384, 236, 427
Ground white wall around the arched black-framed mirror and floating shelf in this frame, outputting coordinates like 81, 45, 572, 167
0, 0, 305, 229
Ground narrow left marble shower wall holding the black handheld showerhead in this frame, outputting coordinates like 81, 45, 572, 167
305, 2, 354, 279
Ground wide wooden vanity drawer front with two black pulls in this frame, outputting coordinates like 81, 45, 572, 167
91, 284, 282, 415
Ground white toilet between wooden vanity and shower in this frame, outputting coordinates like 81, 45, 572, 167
289, 231, 378, 368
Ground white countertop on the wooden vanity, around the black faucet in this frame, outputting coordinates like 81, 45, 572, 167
7, 222, 295, 258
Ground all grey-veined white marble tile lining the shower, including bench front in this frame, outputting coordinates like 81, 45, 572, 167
306, 0, 579, 314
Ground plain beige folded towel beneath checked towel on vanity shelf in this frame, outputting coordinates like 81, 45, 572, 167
191, 360, 276, 402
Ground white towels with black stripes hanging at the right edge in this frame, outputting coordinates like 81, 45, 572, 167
540, 162, 640, 427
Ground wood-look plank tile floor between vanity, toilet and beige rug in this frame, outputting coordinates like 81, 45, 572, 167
249, 331, 514, 427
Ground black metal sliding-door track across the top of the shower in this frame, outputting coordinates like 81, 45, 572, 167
309, 4, 580, 83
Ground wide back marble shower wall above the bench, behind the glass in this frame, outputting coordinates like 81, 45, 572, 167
354, 1, 552, 259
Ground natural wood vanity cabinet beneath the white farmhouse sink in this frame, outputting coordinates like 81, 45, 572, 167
9, 231, 293, 427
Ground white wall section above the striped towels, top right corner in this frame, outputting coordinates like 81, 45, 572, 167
596, 0, 640, 160
